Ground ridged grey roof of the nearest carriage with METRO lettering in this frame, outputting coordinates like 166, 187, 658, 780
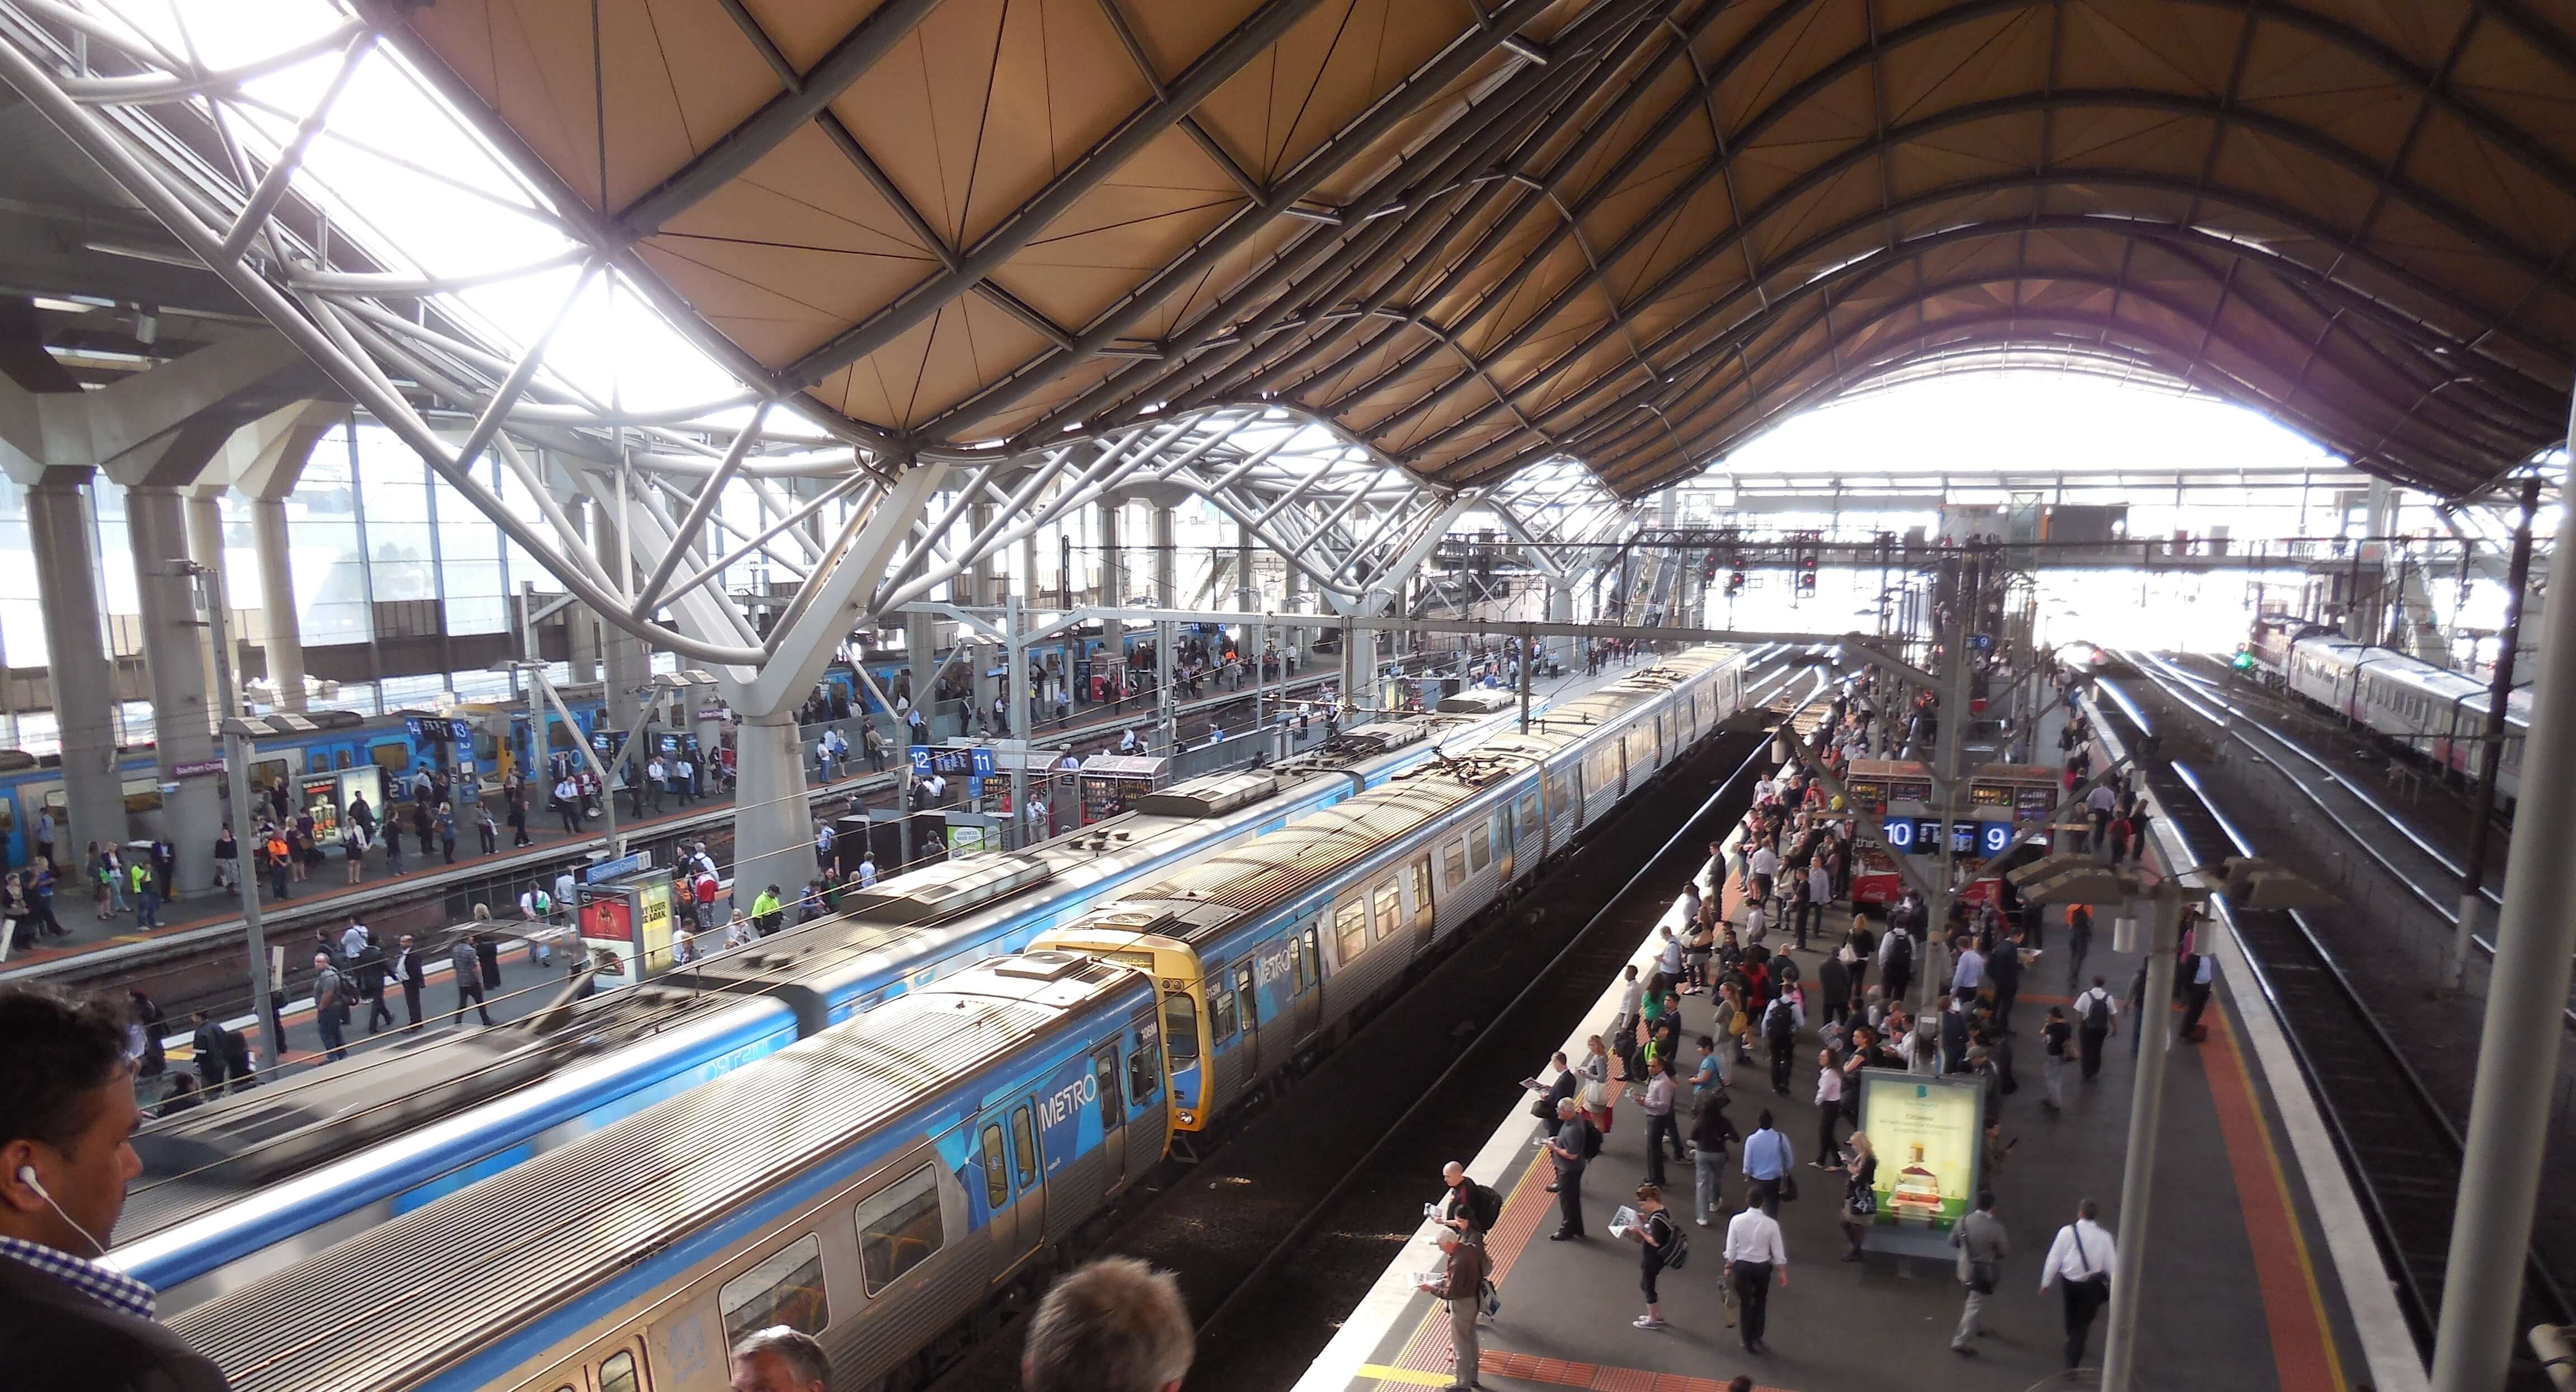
170, 962, 1144, 1392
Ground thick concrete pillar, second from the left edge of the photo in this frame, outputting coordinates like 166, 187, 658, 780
126, 487, 224, 892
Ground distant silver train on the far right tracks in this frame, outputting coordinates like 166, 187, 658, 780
2244, 619, 2532, 812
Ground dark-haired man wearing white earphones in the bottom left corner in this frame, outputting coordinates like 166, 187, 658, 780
0, 987, 227, 1392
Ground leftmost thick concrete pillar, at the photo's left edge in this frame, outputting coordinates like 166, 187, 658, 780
26, 469, 129, 866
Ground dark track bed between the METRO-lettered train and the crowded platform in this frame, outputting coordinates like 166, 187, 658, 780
933, 673, 1821, 1392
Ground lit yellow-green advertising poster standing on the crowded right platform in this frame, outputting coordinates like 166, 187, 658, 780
1860, 1067, 1986, 1255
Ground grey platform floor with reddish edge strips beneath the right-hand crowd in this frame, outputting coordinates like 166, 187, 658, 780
1296, 763, 2424, 1392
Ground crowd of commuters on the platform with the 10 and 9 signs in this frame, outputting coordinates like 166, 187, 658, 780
1422, 675, 2213, 1392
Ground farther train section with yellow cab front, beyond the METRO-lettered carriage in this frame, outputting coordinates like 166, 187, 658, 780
1036, 647, 1744, 1134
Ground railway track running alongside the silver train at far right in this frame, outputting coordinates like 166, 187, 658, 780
2123, 652, 2576, 1026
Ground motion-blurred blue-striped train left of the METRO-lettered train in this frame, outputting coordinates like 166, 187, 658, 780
108, 652, 1731, 1310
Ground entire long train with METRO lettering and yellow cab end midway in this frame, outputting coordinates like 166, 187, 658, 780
170, 647, 1744, 1392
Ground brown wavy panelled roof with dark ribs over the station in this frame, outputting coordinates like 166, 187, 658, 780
387, 0, 2576, 495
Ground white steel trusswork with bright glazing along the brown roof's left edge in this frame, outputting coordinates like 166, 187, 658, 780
0, 0, 1630, 709
